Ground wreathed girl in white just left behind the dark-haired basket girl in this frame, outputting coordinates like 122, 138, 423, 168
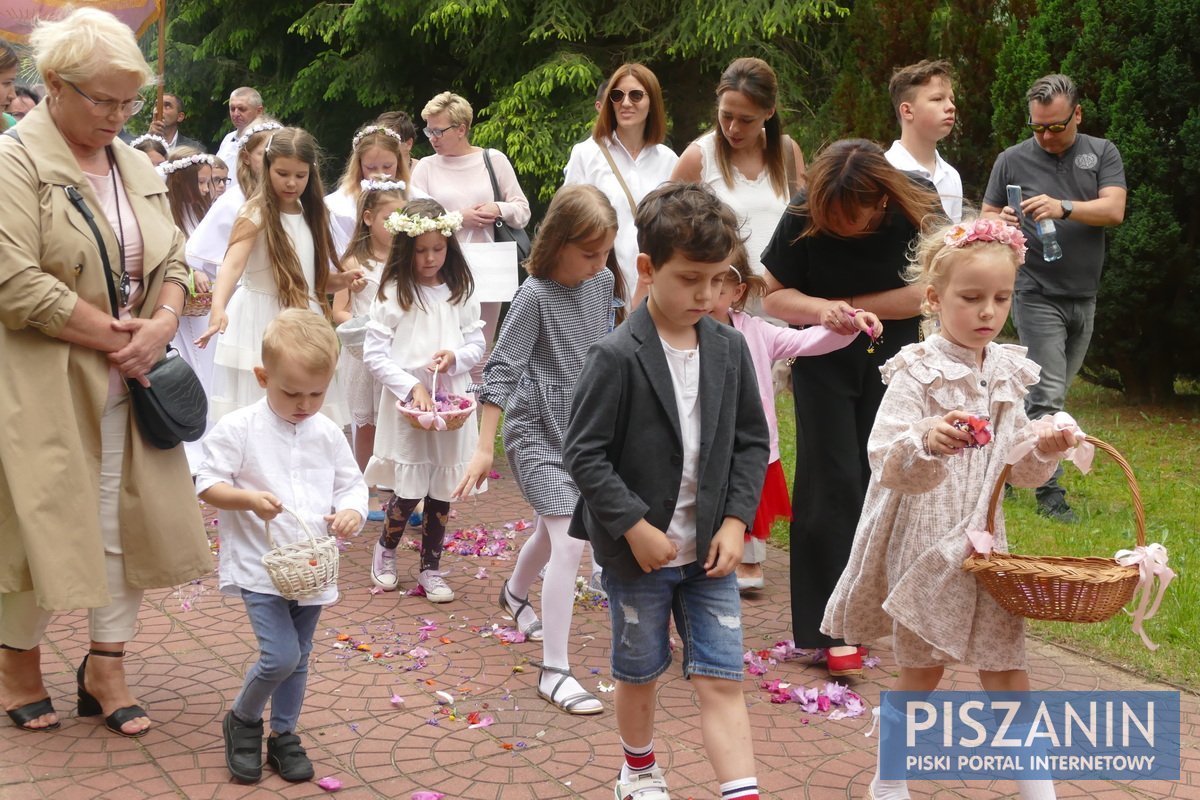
334, 180, 404, 479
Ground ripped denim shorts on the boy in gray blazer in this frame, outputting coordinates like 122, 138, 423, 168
601, 561, 743, 684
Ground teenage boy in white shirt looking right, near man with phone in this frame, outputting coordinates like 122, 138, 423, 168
886, 60, 962, 222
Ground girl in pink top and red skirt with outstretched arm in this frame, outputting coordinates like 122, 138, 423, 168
708, 246, 883, 591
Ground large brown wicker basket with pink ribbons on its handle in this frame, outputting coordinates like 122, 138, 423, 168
962, 437, 1146, 622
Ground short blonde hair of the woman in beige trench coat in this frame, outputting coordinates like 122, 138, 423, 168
29, 7, 158, 86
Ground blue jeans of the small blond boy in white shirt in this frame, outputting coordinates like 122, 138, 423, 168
233, 589, 320, 733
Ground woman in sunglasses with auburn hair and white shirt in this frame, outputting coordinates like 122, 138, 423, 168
563, 64, 679, 305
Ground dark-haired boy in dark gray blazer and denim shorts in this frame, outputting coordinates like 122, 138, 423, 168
563, 184, 768, 800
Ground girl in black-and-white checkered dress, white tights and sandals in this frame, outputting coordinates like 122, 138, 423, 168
456, 185, 624, 714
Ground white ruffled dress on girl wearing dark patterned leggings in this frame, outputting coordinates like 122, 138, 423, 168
364, 284, 484, 500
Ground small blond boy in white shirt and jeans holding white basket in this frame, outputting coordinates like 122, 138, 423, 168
196, 308, 367, 783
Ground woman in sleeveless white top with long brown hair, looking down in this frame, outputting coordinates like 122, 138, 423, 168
671, 58, 804, 280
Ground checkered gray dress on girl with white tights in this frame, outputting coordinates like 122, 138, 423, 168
478, 270, 613, 516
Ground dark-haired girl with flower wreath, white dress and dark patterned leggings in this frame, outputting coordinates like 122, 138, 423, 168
362, 200, 485, 603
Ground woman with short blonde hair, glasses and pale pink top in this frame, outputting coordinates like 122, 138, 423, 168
410, 91, 529, 344
